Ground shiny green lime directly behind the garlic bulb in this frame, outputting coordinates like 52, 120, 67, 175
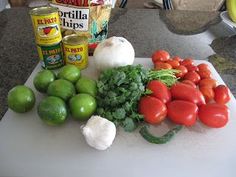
69, 93, 97, 120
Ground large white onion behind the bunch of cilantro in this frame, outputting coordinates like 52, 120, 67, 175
93, 36, 135, 71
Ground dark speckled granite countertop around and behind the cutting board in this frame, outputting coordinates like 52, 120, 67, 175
0, 8, 236, 117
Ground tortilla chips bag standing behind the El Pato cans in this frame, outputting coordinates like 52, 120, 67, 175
50, 0, 112, 49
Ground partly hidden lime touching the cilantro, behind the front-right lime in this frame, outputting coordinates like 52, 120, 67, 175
75, 76, 97, 97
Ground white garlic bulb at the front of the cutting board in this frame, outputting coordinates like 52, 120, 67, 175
82, 116, 116, 150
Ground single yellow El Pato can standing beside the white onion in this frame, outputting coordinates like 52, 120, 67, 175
62, 34, 88, 69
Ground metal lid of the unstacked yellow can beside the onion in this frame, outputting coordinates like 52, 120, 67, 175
62, 34, 88, 45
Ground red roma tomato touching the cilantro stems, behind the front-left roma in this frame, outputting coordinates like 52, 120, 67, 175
147, 80, 171, 103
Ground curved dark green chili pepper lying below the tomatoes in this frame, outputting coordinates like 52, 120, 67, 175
139, 125, 183, 144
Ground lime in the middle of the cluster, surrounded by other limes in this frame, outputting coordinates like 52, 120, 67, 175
47, 79, 75, 101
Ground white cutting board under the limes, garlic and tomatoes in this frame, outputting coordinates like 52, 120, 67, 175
0, 58, 236, 177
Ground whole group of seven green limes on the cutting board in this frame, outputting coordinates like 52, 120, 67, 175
8, 65, 97, 125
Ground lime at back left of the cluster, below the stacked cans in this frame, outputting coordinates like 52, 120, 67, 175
33, 70, 56, 93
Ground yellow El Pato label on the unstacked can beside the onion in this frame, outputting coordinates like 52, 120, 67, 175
63, 44, 88, 69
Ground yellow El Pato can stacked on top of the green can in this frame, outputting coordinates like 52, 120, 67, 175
30, 6, 62, 46
